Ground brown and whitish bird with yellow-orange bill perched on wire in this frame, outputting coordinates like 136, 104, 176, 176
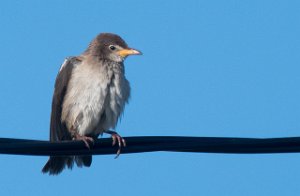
42, 33, 142, 175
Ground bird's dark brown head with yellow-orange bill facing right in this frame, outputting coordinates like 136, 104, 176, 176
86, 33, 142, 62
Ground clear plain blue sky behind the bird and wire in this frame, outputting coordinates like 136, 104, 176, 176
0, 0, 300, 196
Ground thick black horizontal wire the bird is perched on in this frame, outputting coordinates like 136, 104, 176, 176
0, 136, 300, 156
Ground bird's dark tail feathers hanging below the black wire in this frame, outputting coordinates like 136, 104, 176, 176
42, 155, 92, 175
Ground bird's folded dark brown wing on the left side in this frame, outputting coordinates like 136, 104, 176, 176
50, 57, 80, 141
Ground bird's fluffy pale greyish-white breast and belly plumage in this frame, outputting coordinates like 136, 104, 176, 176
62, 60, 130, 135
